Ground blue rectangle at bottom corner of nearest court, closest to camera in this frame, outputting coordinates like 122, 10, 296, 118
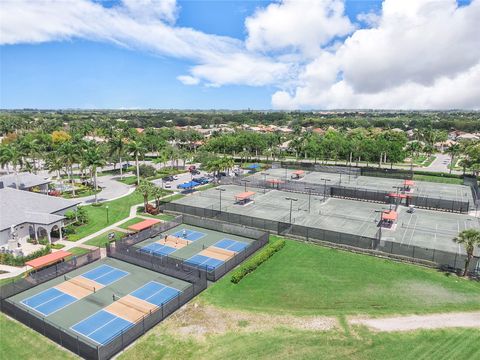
71, 310, 133, 345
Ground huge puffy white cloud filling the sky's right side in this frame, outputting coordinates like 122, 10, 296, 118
272, 0, 480, 109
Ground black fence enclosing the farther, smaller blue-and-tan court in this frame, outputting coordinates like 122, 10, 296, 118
112, 215, 269, 281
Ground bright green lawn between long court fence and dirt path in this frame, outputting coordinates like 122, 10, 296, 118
200, 240, 480, 316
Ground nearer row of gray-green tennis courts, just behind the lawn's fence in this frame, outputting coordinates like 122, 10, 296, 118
173, 186, 480, 260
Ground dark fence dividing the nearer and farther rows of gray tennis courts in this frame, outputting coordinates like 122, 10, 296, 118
221, 177, 470, 213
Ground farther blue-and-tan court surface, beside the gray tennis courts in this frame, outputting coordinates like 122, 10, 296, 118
136, 224, 254, 271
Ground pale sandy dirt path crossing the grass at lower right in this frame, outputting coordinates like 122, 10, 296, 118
349, 312, 480, 331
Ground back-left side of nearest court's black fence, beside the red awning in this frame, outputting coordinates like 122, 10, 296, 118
0, 249, 100, 300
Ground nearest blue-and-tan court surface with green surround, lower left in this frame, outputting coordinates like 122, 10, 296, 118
7, 258, 191, 346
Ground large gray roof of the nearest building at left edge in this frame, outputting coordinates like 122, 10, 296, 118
0, 188, 78, 231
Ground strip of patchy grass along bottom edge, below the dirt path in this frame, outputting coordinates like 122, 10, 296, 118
119, 328, 480, 360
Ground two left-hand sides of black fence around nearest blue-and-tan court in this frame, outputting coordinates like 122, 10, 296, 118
0, 249, 100, 359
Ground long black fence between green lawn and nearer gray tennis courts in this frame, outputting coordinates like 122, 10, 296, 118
162, 202, 479, 273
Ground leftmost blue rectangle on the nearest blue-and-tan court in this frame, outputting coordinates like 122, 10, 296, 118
21, 287, 77, 316
